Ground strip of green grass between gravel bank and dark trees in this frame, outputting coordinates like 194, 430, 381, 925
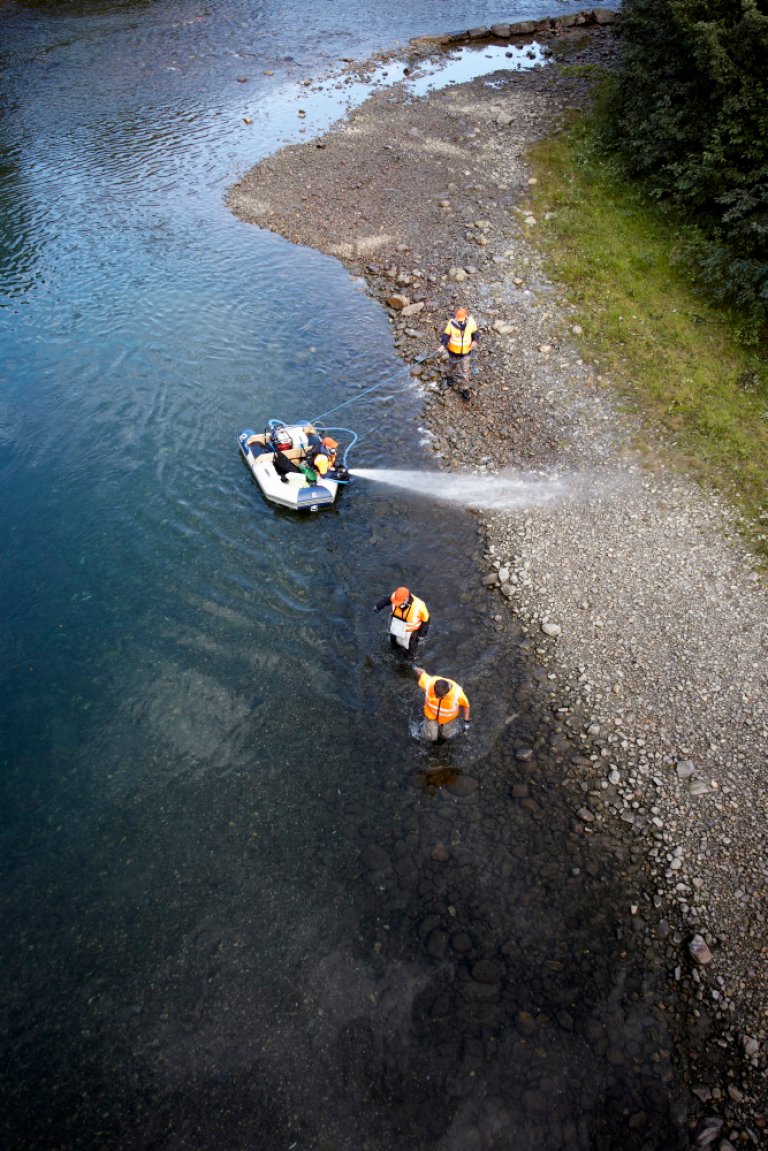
527, 105, 768, 558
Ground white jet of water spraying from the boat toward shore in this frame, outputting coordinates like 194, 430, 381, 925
350, 467, 570, 511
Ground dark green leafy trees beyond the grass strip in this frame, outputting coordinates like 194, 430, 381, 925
611, 0, 768, 331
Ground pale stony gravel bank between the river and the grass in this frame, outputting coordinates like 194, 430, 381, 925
229, 9, 768, 1149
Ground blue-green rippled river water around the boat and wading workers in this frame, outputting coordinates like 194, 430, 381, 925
0, 0, 679, 1151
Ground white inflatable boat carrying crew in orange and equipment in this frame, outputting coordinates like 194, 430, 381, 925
237, 420, 351, 511
